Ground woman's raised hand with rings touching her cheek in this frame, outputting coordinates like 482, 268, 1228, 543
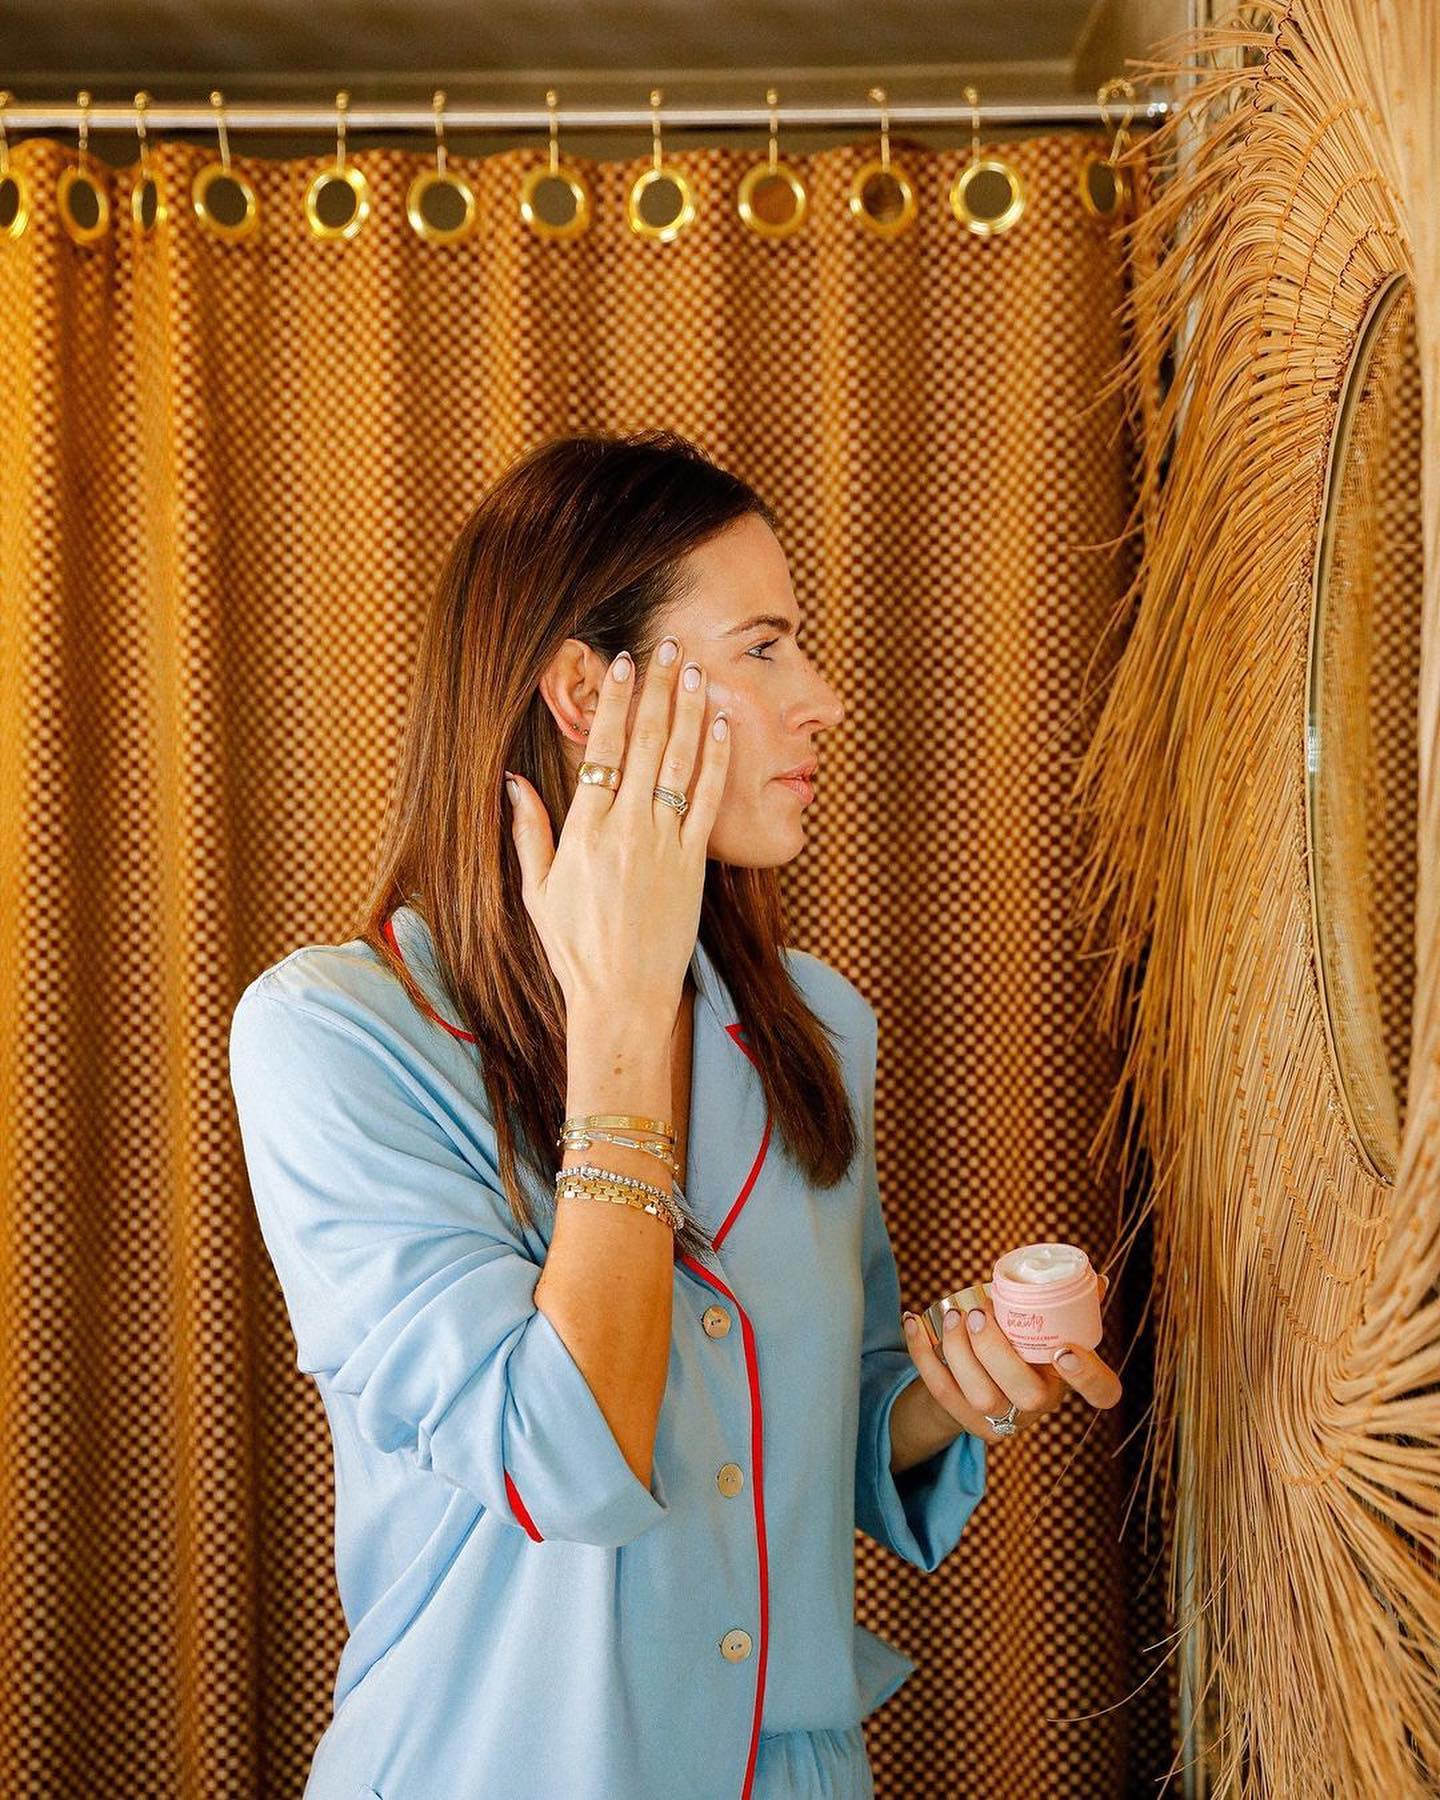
511, 637, 729, 1021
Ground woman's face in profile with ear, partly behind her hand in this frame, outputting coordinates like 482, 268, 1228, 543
542, 513, 844, 868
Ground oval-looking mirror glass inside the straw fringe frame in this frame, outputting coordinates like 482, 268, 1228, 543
1305, 275, 1424, 1181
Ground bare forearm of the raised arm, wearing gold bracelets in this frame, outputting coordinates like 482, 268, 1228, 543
535, 1012, 675, 1487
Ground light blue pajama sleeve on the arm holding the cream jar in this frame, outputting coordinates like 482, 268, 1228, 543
855, 1001, 986, 1573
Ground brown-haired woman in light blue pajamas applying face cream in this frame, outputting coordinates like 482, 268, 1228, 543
230, 432, 1118, 1800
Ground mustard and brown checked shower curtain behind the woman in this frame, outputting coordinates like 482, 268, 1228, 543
0, 133, 1172, 1800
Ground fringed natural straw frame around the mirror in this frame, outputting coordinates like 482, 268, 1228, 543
1076, 0, 1440, 1800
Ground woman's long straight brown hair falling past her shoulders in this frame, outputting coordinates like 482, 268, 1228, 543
356, 430, 857, 1228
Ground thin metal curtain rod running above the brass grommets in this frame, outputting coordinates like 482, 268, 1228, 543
0, 97, 1174, 133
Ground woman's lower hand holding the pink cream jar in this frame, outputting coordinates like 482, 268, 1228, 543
905, 1274, 1123, 1444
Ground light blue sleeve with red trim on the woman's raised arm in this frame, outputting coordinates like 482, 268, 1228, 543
230, 976, 668, 1546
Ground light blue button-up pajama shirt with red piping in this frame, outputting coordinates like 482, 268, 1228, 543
230, 905, 985, 1800
